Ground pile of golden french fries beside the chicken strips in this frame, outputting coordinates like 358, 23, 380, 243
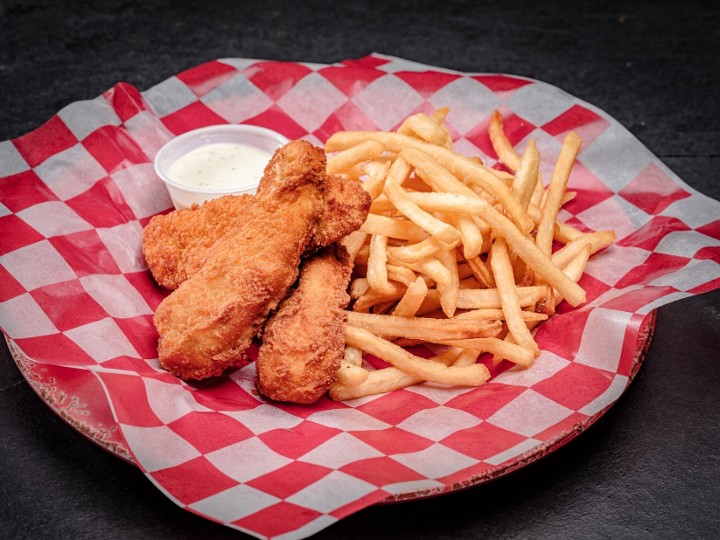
325, 108, 615, 400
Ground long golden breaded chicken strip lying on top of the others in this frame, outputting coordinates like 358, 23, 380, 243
154, 141, 326, 380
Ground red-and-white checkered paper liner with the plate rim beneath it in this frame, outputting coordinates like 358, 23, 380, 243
0, 55, 720, 539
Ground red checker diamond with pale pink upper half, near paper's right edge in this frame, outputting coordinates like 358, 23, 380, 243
619, 163, 690, 214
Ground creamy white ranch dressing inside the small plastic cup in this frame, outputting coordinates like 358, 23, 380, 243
167, 143, 272, 190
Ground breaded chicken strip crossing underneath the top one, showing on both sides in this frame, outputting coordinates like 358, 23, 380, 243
142, 175, 370, 289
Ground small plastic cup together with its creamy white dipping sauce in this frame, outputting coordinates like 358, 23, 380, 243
155, 124, 288, 209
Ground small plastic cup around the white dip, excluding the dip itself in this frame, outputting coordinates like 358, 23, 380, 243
154, 124, 288, 210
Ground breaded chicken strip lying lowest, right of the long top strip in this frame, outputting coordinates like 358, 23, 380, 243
255, 244, 352, 404
